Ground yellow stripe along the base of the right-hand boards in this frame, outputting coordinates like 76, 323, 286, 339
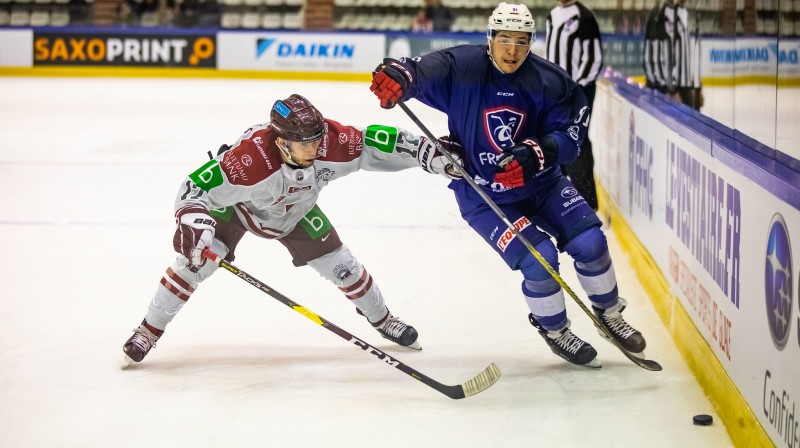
597, 184, 774, 447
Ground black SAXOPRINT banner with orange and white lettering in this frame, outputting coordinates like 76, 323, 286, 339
33, 31, 217, 67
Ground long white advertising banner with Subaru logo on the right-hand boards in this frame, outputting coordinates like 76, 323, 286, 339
592, 83, 800, 448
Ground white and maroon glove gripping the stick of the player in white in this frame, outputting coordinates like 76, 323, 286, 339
172, 205, 217, 272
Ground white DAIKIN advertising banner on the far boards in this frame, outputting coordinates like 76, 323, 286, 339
217, 32, 386, 73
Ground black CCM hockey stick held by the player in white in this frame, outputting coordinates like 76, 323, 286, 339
203, 248, 500, 400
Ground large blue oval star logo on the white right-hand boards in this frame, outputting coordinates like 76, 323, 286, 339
764, 213, 793, 350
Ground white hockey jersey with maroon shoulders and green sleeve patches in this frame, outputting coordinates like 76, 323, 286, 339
175, 119, 419, 238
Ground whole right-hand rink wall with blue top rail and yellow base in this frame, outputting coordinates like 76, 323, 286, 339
591, 77, 800, 448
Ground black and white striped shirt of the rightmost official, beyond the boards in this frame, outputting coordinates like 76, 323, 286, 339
643, 3, 699, 93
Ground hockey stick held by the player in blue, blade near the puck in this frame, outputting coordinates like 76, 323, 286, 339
397, 101, 661, 371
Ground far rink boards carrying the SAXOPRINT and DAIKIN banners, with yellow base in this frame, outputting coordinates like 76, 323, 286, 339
0, 27, 485, 82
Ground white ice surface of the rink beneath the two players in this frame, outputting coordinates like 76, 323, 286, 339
0, 78, 731, 448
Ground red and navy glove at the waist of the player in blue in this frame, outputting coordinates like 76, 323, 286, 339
494, 138, 556, 188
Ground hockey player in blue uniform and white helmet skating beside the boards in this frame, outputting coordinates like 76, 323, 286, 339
370, 3, 645, 367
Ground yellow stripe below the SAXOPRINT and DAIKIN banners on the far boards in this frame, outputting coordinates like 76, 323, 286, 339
0, 66, 372, 82
